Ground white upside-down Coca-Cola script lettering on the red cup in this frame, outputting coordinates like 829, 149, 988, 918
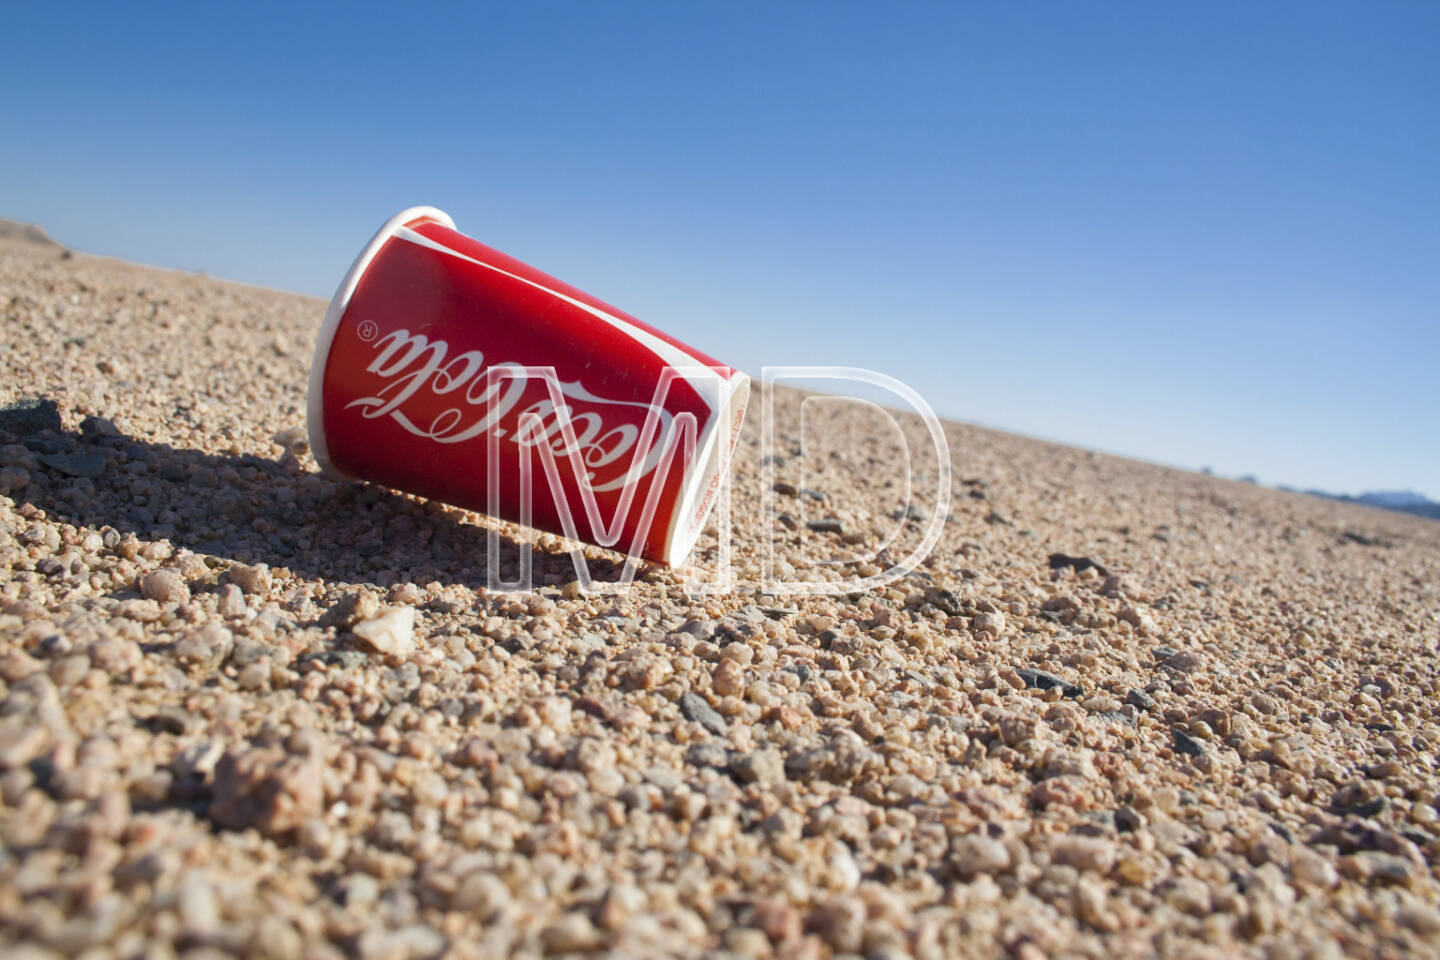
346, 332, 685, 492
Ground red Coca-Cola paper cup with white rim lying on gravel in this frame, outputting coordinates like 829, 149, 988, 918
308, 207, 750, 564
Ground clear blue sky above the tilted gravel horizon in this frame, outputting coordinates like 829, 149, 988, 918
0, 1, 1440, 499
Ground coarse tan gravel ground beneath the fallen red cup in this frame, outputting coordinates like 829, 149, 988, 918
0, 230, 1440, 960
